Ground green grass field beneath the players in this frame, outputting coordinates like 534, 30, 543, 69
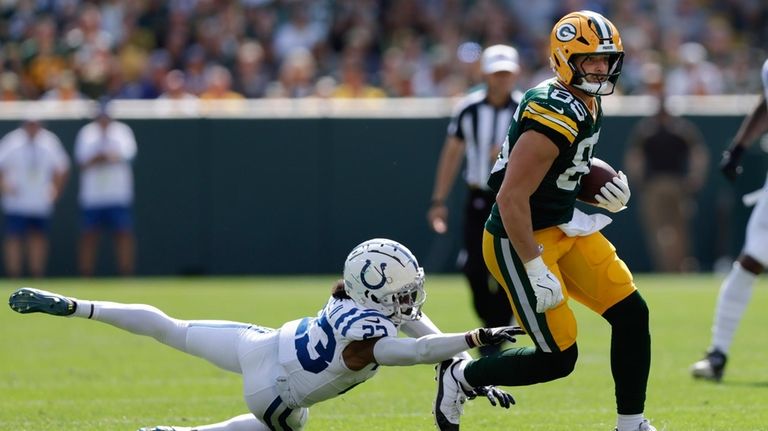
0, 276, 768, 431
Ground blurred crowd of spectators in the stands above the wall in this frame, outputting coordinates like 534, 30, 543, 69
0, 0, 768, 100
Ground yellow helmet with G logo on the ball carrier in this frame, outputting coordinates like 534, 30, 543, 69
549, 10, 624, 95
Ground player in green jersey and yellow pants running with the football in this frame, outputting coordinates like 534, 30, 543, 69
436, 11, 655, 431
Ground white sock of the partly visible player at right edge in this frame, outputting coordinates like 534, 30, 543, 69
710, 262, 757, 353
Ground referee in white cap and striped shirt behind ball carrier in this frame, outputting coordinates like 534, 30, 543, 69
427, 45, 520, 355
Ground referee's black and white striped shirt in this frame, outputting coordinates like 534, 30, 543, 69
448, 89, 522, 190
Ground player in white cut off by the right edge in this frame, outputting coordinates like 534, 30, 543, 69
691, 60, 768, 382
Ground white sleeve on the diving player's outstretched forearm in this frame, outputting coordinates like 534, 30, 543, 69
373, 334, 469, 366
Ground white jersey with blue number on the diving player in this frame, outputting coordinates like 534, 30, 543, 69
278, 297, 397, 408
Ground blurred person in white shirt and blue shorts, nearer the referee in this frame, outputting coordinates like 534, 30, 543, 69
75, 102, 136, 277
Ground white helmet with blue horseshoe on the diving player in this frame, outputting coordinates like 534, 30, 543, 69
344, 238, 427, 324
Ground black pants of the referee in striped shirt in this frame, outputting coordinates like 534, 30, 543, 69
463, 189, 512, 327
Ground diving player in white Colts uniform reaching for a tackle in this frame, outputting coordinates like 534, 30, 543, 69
9, 239, 523, 431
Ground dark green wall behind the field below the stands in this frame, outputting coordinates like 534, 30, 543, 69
0, 117, 766, 276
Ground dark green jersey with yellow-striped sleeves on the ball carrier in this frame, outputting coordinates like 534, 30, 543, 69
485, 78, 603, 237
